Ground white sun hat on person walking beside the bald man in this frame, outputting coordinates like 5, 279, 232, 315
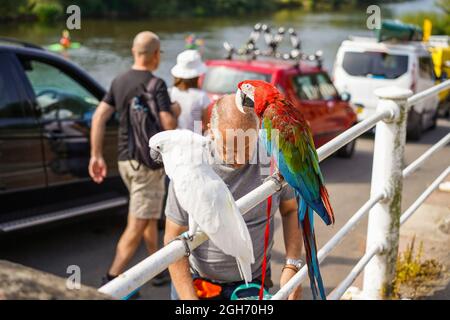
171, 50, 208, 79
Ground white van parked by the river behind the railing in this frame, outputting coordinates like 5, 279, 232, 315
333, 37, 439, 140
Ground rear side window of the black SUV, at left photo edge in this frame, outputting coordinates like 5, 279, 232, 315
0, 53, 30, 120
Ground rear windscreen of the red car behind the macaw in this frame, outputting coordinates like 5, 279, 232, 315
203, 66, 271, 94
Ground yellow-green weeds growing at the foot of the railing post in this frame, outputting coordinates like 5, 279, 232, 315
393, 237, 443, 298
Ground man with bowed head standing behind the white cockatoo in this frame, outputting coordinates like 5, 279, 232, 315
164, 95, 302, 300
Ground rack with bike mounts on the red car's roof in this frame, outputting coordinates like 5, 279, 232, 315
223, 23, 323, 68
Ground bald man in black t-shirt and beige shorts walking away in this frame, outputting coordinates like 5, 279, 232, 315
89, 31, 177, 290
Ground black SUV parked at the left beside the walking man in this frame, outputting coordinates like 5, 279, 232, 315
0, 39, 127, 233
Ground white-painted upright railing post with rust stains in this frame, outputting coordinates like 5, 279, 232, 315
363, 87, 412, 299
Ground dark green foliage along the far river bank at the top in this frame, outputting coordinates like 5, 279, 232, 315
0, 0, 444, 22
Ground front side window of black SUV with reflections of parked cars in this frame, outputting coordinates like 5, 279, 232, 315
22, 60, 99, 120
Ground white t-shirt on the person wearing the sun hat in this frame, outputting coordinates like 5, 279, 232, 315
169, 87, 211, 131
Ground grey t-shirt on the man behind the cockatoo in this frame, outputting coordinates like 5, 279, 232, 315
165, 159, 295, 282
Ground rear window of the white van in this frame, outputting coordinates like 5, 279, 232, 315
342, 51, 408, 79
